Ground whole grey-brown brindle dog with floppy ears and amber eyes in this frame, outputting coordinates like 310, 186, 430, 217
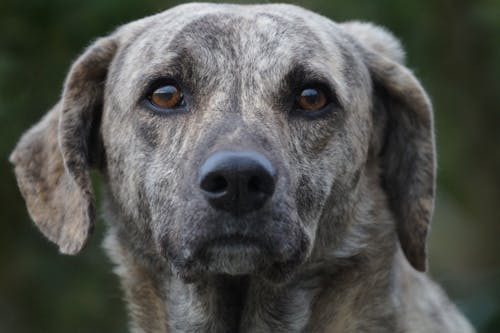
10, 4, 474, 333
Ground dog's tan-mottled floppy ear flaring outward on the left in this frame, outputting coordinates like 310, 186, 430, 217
10, 37, 117, 254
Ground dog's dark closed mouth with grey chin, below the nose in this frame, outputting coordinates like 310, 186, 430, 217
162, 206, 311, 283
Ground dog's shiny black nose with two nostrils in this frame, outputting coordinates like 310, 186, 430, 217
199, 151, 276, 215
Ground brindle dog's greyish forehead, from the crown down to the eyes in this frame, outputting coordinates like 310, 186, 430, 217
108, 3, 355, 110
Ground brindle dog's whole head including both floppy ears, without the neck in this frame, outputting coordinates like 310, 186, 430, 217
11, 4, 434, 280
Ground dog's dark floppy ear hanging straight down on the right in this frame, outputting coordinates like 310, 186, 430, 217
342, 22, 436, 271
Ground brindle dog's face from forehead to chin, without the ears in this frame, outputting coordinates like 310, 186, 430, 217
102, 5, 371, 276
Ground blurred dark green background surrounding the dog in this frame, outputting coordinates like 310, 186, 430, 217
0, 0, 500, 333
